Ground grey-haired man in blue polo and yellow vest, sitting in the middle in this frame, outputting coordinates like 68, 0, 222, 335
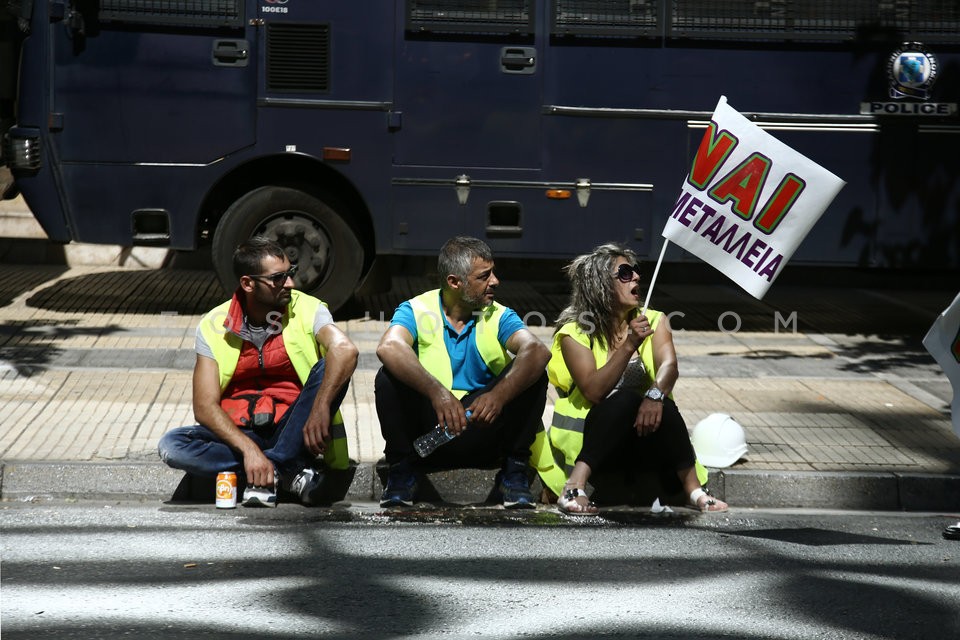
374, 237, 550, 508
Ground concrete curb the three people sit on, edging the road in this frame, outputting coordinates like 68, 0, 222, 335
0, 462, 960, 512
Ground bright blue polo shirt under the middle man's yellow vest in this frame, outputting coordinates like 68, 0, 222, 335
390, 293, 526, 393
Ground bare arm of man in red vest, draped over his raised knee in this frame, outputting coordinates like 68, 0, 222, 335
303, 324, 360, 456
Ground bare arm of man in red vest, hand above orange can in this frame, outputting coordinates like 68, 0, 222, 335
193, 355, 274, 487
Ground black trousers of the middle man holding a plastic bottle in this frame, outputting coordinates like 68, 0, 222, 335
374, 365, 547, 469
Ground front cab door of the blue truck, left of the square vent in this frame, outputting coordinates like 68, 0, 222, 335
50, 0, 256, 164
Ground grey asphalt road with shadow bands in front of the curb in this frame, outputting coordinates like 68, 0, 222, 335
0, 502, 960, 640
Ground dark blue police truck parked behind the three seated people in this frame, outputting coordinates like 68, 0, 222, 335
0, 0, 960, 307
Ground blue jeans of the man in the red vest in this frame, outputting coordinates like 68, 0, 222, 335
157, 360, 349, 477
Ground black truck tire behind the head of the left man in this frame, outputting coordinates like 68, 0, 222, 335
211, 186, 363, 310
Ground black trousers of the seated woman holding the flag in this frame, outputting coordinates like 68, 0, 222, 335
577, 389, 696, 477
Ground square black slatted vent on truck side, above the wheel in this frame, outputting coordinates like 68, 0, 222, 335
267, 24, 330, 93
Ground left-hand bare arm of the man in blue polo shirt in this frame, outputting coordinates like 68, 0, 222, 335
377, 325, 467, 433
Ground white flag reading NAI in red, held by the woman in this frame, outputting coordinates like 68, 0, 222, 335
656, 97, 846, 302
